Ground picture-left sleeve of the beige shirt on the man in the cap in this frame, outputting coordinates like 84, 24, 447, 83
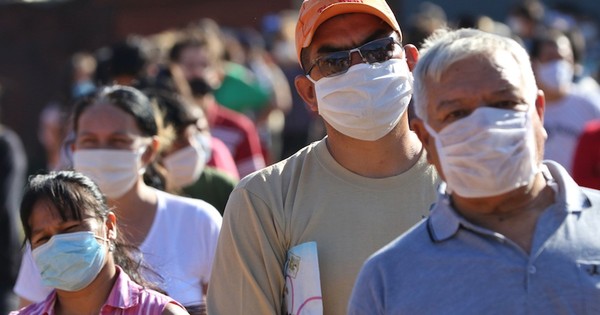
207, 188, 287, 315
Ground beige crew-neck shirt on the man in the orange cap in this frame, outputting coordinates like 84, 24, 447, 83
208, 140, 438, 315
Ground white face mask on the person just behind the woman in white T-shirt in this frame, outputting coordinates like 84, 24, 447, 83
164, 137, 207, 188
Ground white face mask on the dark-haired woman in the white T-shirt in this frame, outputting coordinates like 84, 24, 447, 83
73, 148, 145, 199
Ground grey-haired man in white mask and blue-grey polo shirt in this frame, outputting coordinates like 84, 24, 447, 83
348, 29, 600, 315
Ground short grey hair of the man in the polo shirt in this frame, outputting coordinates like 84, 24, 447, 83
413, 29, 538, 122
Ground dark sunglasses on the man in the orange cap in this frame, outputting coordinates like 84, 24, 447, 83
306, 36, 401, 77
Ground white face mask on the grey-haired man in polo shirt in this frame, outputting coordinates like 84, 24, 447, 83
425, 107, 539, 198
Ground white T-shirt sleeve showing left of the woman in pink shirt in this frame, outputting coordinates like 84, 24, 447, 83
14, 244, 52, 303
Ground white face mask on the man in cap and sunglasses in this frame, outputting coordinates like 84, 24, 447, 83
308, 59, 413, 141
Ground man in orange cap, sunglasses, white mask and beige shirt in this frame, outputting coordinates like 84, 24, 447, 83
207, 0, 438, 314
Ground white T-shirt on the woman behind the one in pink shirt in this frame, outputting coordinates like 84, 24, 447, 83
14, 190, 222, 305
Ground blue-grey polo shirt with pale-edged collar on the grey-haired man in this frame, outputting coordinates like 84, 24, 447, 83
349, 161, 600, 315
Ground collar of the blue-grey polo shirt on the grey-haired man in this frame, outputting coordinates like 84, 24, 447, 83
427, 161, 591, 242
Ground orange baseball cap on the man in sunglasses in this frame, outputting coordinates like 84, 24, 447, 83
296, 0, 400, 67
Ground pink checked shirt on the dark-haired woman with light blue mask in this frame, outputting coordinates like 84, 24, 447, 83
9, 266, 183, 315
